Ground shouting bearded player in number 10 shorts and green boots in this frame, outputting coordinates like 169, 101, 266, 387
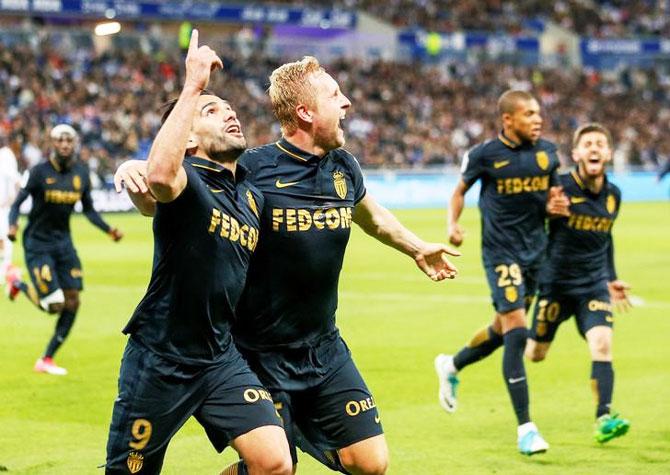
526, 123, 630, 443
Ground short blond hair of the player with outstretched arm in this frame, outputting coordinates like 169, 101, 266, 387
268, 56, 324, 134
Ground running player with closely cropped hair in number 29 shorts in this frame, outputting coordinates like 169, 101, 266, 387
435, 90, 568, 455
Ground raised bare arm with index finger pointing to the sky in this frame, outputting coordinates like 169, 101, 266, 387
147, 29, 223, 203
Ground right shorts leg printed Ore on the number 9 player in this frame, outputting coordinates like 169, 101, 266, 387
195, 357, 288, 456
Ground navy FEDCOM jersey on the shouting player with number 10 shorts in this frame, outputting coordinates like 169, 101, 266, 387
540, 170, 621, 288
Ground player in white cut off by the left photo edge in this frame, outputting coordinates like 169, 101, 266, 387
0, 134, 21, 279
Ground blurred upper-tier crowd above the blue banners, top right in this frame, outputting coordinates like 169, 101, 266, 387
275, 0, 670, 38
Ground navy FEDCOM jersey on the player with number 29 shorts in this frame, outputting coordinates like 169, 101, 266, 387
461, 134, 560, 266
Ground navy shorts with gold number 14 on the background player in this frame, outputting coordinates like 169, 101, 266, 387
25, 244, 84, 299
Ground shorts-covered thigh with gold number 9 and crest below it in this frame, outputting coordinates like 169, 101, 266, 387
106, 339, 204, 474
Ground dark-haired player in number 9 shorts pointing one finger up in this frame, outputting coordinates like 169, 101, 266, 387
106, 30, 291, 475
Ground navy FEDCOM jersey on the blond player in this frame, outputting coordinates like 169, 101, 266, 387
234, 139, 365, 349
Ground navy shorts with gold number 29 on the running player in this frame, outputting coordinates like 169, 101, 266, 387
484, 258, 539, 313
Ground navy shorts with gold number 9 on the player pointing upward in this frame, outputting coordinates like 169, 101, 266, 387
106, 338, 282, 474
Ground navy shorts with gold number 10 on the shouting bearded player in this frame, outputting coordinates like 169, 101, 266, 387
528, 284, 614, 343
